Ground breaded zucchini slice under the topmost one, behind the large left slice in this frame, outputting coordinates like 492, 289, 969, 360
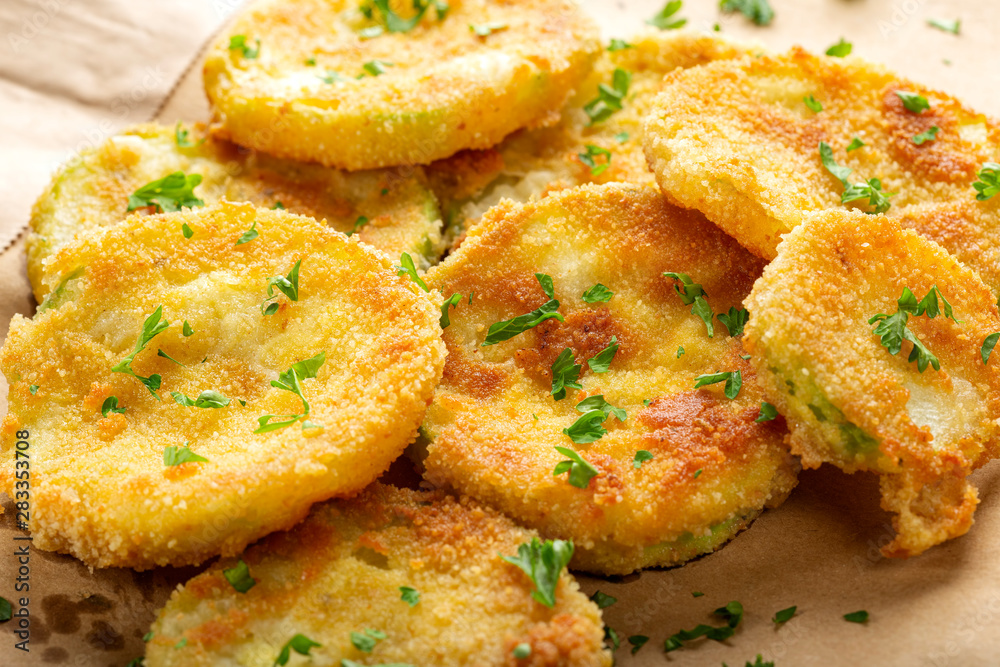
27, 123, 443, 301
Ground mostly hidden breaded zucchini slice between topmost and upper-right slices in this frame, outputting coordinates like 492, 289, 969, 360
428, 29, 759, 243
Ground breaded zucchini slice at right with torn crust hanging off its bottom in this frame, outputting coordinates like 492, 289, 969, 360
746, 211, 1000, 556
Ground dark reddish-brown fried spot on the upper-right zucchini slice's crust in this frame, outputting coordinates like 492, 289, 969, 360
882, 83, 978, 183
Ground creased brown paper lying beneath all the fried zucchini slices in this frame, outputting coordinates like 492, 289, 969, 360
0, 0, 1000, 667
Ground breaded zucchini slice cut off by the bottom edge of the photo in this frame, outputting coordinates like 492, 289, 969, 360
146, 484, 611, 667
